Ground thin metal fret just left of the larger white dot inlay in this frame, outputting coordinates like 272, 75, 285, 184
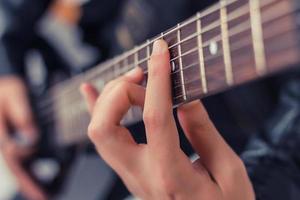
197, 13, 207, 93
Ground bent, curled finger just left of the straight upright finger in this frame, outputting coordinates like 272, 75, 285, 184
88, 69, 145, 169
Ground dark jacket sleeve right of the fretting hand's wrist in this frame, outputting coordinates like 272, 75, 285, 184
242, 76, 300, 200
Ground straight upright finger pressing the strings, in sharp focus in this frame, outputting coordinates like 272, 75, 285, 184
143, 40, 179, 155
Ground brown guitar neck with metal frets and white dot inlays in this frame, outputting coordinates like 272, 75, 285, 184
44, 0, 300, 145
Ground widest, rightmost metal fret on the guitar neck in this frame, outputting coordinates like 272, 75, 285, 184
249, 0, 267, 75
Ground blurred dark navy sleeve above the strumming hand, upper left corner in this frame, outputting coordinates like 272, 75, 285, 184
0, 0, 51, 75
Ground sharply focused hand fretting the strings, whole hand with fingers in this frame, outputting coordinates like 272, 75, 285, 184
81, 40, 255, 200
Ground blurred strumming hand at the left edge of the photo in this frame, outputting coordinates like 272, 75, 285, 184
0, 75, 46, 200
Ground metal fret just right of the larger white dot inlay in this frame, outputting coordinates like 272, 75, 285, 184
220, 0, 233, 85
